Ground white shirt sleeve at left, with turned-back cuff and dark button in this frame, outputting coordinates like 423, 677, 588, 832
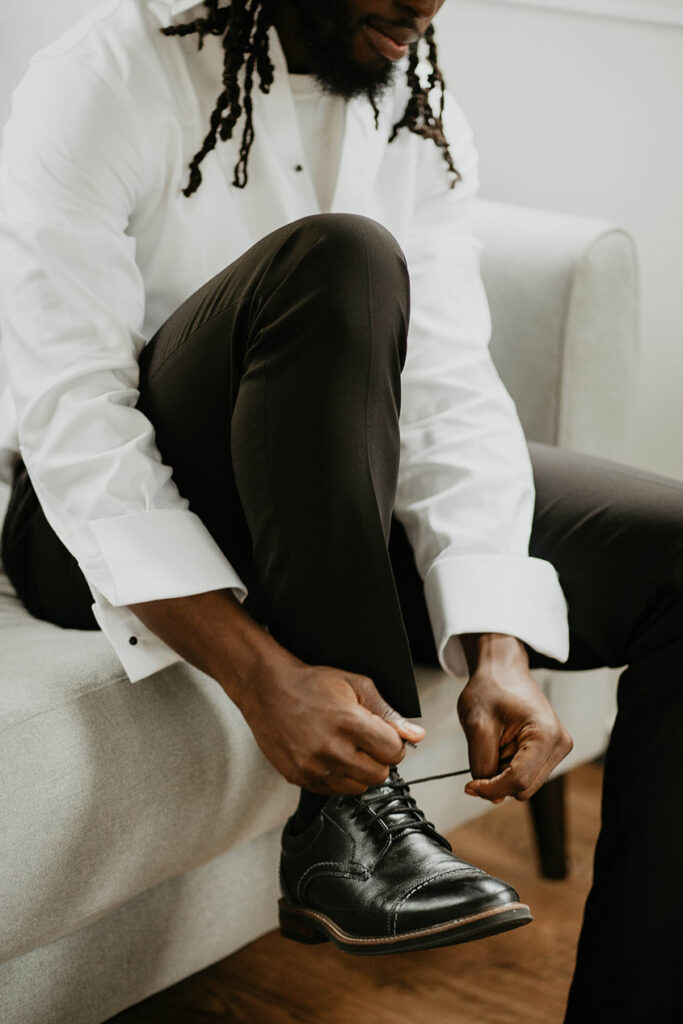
0, 53, 247, 681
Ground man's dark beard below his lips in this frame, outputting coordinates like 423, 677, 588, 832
284, 0, 396, 105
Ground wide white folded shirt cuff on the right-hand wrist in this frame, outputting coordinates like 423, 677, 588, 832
425, 555, 569, 679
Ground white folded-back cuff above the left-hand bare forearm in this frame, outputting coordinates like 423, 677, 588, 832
81, 509, 247, 607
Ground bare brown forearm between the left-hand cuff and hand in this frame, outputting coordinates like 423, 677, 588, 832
130, 590, 301, 705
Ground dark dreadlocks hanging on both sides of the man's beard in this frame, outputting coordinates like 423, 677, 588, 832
161, 0, 462, 197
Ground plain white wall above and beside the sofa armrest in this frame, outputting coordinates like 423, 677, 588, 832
438, 0, 683, 478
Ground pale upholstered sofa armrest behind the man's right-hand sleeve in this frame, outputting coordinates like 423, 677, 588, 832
474, 200, 639, 459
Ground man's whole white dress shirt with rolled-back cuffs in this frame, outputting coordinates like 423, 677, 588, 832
0, 0, 568, 681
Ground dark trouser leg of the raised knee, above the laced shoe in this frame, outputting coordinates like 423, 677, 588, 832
1, 215, 420, 716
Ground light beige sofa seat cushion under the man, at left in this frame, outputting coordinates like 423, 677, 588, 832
0, 552, 305, 959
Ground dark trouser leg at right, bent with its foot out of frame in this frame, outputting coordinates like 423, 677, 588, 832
530, 445, 683, 1024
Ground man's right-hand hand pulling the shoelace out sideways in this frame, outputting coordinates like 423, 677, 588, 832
458, 633, 573, 804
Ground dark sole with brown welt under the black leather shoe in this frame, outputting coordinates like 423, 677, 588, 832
279, 899, 533, 956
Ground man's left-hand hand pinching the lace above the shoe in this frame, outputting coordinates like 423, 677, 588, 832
238, 656, 425, 796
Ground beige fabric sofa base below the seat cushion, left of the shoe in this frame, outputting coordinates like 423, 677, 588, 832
0, 827, 280, 1024
